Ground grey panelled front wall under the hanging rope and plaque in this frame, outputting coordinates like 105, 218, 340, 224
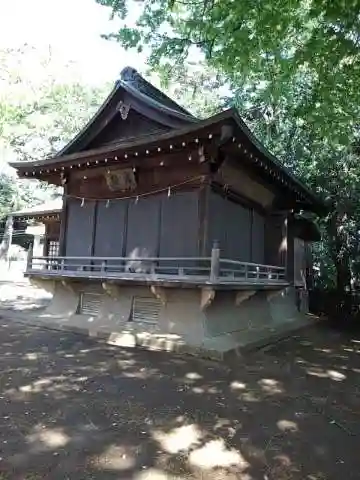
65, 191, 199, 257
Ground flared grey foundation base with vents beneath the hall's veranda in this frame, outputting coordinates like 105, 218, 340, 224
28, 279, 307, 358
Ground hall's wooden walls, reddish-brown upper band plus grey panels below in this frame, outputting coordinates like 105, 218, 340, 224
60, 154, 287, 265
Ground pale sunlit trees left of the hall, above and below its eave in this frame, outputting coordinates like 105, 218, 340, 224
0, 45, 110, 255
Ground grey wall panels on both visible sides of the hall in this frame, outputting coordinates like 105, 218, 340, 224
65, 191, 270, 264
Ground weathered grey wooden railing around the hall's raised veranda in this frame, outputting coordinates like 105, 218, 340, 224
27, 244, 286, 284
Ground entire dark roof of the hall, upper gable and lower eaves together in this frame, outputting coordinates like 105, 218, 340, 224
11, 67, 324, 216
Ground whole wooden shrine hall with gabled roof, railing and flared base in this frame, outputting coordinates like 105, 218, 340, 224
12, 67, 324, 356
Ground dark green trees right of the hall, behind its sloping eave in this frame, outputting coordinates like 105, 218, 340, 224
239, 78, 360, 293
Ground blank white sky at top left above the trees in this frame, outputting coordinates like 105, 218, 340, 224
0, 0, 145, 85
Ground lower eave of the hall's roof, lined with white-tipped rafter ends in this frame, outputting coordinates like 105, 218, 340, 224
11, 109, 326, 215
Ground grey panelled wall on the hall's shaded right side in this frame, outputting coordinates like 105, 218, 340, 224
207, 192, 265, 263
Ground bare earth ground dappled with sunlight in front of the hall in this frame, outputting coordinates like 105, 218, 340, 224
0, 285, 360, 480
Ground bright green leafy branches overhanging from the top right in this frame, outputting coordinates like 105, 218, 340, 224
98, 0, 360, 144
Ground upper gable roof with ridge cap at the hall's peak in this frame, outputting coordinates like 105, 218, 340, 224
56, 67, 198, 157
